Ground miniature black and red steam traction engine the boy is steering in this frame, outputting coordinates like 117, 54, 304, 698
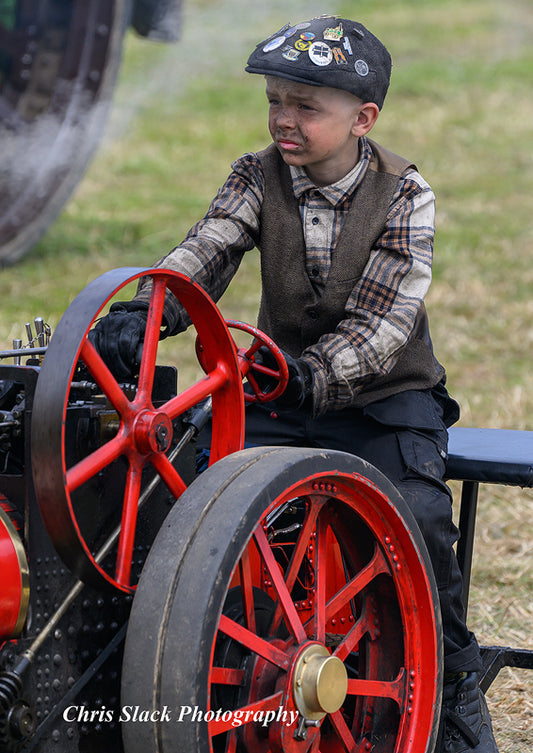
0, 269, 441, 753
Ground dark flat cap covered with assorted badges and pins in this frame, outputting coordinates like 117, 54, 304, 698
246, 16, 392, 109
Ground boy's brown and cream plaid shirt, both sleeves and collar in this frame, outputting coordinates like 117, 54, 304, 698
158, 138, 435, 415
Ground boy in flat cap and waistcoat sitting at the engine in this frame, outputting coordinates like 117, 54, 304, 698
93, 16, 497, 753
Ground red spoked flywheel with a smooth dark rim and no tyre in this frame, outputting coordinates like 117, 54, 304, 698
31, 268, 244, 591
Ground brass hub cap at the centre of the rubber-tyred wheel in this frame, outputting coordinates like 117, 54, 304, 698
293, 644, 348, 720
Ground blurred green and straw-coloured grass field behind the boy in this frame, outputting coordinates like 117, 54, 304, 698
0, 0, 533, 753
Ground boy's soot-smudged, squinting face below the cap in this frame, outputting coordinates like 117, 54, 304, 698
266, 76, 379, 186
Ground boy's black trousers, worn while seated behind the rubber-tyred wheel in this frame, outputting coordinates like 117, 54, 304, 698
241, 386, 481, 672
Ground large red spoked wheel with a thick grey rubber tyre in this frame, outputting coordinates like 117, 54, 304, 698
122, 448, 442, 753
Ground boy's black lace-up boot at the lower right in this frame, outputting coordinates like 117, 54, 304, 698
435, 672, 498, 753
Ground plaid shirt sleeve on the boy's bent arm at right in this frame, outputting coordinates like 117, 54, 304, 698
302, 170, 435, 415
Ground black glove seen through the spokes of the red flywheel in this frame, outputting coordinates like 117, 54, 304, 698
89, 301, 148, 382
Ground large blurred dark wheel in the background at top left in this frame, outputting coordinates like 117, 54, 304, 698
0, 0, 130, 266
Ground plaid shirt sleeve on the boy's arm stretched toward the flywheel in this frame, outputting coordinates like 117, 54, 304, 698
136, 154, 264, 334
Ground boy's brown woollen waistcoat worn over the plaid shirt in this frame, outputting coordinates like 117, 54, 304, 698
258, 140, 444, 406
